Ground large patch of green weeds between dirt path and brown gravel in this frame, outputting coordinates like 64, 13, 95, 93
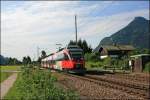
5, 67, 77, 100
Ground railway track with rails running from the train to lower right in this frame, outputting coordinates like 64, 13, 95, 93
62, 73, 149, 99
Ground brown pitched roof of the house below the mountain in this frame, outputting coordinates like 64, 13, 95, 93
93, 45, 134, 52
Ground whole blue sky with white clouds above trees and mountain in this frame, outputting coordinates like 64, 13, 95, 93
1, 1, 149, 60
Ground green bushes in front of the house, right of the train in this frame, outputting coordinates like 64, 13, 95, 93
85, 53, 130, 70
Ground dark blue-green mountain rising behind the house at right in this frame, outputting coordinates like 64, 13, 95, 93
99, 17, 150, 48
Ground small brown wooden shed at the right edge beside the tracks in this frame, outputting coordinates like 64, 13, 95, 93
131, 54, 150, 72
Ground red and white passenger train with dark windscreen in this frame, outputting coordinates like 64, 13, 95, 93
41, 45, 86, 74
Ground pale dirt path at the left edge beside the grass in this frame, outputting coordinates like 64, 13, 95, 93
0, 73, 17, 99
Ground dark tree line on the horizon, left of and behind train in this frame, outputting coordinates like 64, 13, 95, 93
0, 39, 92, 65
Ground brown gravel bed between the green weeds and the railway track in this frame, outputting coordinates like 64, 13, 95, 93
52, 73, 142, 100
